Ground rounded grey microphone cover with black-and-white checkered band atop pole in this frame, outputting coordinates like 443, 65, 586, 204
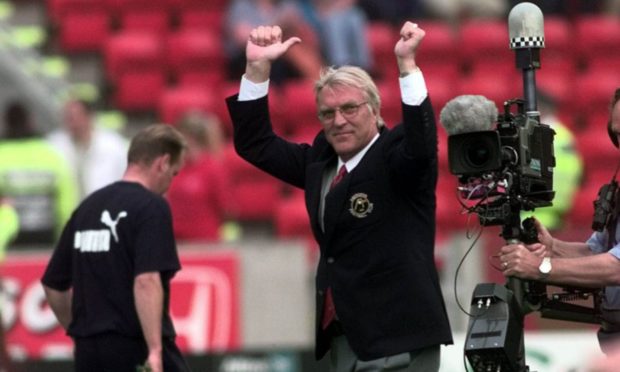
508, 2, 545, 49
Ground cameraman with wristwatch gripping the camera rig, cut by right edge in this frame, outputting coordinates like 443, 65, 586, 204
500, 88, 620, 353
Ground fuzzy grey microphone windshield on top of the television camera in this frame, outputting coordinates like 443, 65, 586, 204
439, 94, 498, 135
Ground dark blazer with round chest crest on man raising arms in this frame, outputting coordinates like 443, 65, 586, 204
227, 96, 452, 360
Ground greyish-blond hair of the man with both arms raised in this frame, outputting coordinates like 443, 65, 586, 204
314, 65, 385, 127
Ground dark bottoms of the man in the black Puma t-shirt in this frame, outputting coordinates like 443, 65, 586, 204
74, 333, 190, 372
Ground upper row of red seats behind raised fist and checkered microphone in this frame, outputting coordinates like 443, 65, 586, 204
368, 15, 620, 78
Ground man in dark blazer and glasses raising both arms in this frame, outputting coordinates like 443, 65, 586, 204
227, 22, 452, 372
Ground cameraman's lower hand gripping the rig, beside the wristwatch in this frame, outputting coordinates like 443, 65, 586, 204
499, 244, 544, 280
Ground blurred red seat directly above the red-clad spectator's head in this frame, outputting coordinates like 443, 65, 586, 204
158, 86, 221, 124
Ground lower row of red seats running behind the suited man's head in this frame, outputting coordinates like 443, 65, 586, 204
151, 60, 620, 143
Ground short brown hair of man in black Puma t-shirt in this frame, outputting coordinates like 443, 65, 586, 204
127, 124, 187, 165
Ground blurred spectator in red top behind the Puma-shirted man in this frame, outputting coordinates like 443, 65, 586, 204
166, 111, 232, 241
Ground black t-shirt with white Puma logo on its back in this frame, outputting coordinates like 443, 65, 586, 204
42, 181, 181, 337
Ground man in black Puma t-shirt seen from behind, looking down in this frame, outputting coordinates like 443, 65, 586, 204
42, 124, 189, 372
